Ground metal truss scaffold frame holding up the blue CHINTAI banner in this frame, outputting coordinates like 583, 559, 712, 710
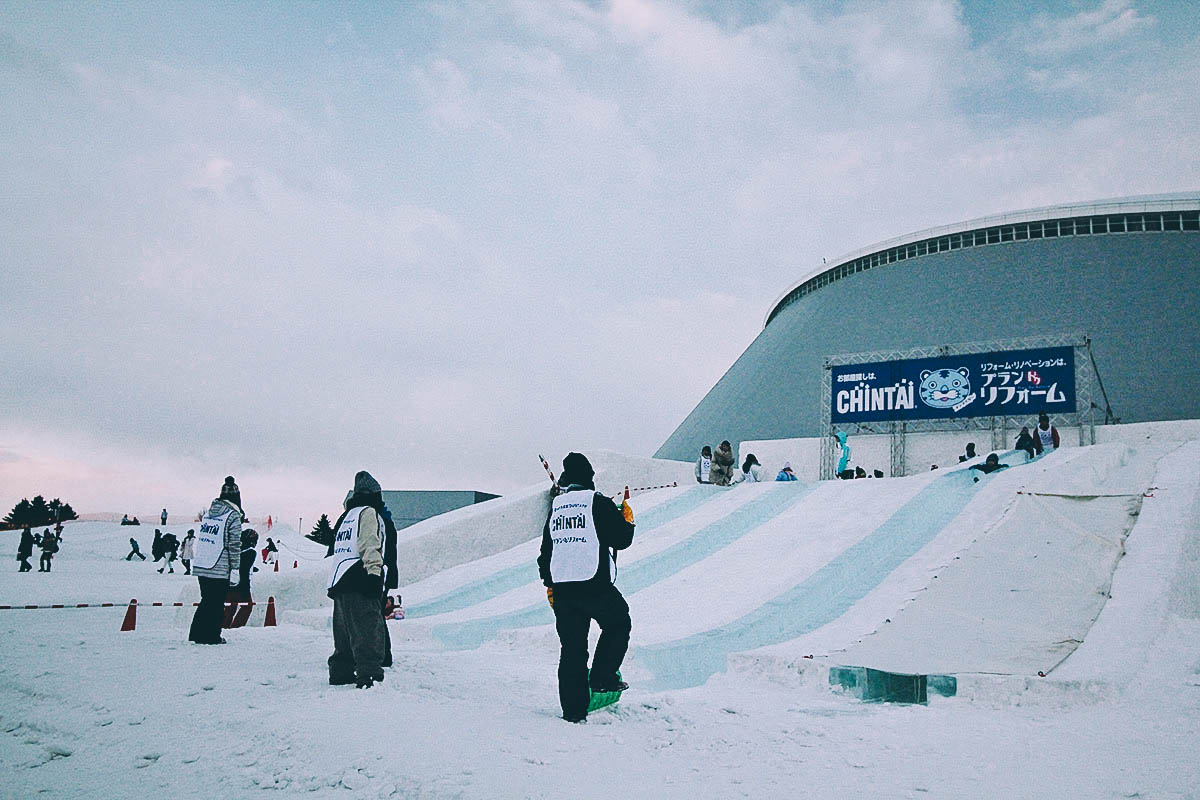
821, 332, 1108, 480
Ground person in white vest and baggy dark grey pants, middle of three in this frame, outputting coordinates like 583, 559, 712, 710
326, 470, 388, 688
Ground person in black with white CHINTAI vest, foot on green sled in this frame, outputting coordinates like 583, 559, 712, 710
538, 452, 634, 722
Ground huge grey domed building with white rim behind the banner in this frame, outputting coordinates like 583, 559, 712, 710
655, 192, 1200, 461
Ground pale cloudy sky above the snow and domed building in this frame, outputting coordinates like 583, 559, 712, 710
0, 0, 1200, 517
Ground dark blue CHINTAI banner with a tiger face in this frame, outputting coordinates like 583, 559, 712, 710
830, 347, 1075, 422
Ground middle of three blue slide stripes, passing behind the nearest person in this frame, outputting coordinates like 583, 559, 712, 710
433, 482, 815, 650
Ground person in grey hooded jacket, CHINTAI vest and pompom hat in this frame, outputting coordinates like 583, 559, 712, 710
187, 475, 242, 644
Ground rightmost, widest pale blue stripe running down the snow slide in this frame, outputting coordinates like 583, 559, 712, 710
636, 471, 977, 690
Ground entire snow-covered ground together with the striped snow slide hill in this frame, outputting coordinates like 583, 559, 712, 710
0, 437, 1200, 798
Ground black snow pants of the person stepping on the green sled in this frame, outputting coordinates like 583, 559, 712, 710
554, 583, 632, 720
